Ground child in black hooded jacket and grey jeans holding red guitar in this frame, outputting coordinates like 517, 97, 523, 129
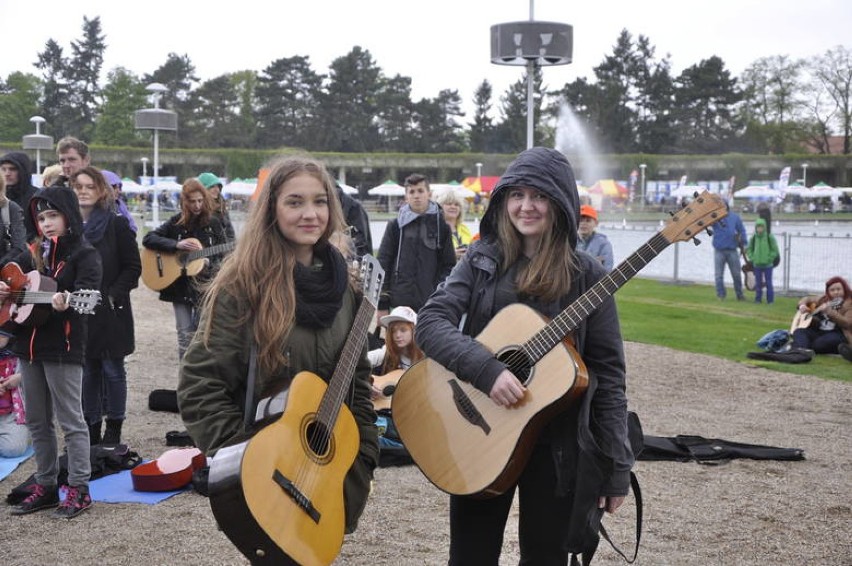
0, 187, 101, 519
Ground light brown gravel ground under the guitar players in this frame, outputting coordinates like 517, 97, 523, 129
0, 288, 852, 566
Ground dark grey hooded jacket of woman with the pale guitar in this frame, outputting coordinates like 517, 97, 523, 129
416, 148, 634, 551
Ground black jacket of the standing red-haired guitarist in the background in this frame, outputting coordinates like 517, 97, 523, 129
142, 213, 228, 305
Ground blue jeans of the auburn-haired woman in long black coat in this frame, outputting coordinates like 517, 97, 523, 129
83, 357, 127, 424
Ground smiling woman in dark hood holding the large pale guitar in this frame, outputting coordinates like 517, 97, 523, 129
417, 147, 633, 565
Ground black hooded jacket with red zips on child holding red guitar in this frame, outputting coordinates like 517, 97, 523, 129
12, 188, 102, 364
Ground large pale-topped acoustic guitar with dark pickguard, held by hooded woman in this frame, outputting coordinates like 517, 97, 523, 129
392, 191, 727, 497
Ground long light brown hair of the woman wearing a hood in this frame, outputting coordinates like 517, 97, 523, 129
492, 189, 577, 301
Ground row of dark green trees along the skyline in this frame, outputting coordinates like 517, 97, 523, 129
0, 17, 852, 158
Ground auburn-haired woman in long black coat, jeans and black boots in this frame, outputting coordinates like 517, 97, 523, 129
70, 166, 142, 445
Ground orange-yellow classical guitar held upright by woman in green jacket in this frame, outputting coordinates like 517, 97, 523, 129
209, 256, 384, 565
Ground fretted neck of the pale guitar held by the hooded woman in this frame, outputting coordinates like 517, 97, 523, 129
523, 234, 671, 363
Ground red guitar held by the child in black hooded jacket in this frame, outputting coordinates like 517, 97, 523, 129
0, 262, 101, 326
